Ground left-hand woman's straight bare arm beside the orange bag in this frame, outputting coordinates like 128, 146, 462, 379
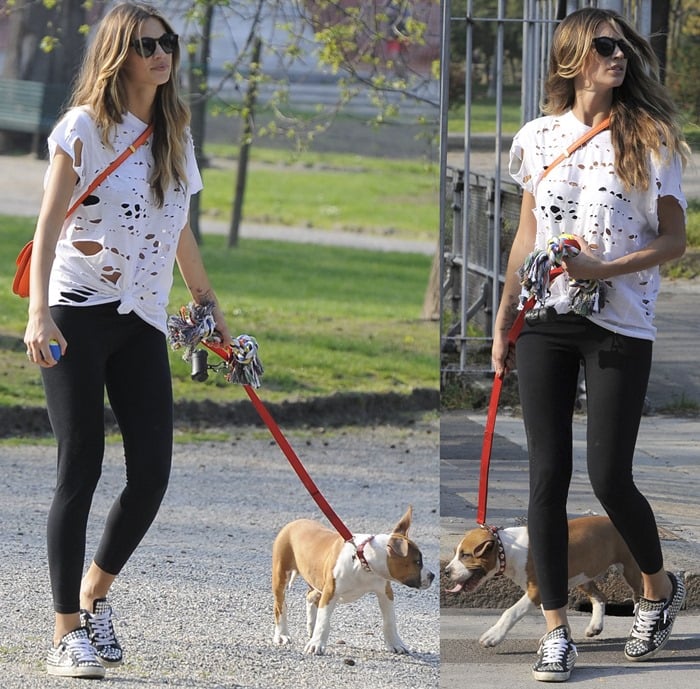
24, 149, 78, 367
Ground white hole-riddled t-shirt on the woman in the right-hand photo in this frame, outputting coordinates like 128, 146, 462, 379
510, 111, 687, 340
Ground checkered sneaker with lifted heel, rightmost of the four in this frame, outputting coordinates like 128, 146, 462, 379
625, 572, 685, 661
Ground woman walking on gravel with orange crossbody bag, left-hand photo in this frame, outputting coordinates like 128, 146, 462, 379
24, 3, 230, 677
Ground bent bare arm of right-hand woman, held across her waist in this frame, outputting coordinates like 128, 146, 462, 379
564, 196, 686, 280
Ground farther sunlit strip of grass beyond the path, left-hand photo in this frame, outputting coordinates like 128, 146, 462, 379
202, 145, 439, 241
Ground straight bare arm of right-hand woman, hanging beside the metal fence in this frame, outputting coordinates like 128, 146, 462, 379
491, 191, 537, 376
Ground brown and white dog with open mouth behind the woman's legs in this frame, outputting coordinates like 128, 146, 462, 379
445, 517, 642, 646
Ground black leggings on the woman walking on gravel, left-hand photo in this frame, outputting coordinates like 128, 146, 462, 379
41, 304, 173, 614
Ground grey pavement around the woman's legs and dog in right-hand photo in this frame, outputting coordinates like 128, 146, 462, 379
440, 412, 700, 689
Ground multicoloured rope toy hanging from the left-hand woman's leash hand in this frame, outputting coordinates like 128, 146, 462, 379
168, 302, 265, 388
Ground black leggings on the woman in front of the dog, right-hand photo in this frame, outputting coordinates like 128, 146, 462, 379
516, 318, 663, 610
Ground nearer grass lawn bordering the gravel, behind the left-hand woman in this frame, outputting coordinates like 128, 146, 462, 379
0, 217, 439, 407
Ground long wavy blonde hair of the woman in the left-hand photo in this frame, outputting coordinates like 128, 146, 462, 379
70, 3, 190, 207
